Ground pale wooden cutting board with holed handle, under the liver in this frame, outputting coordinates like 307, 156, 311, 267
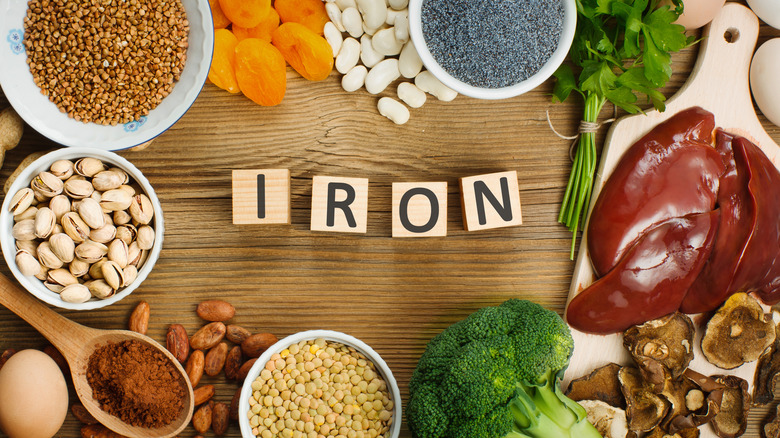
564, 3, 780, 438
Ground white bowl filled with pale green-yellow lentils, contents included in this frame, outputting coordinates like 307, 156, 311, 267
238, 330, 401, 438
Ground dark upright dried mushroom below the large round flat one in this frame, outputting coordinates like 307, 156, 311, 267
711, 376, 750, 438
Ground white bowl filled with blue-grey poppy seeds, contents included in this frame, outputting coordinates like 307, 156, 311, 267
409, 0, 577, 99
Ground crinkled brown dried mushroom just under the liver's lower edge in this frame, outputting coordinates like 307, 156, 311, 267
623, 312, 694, 386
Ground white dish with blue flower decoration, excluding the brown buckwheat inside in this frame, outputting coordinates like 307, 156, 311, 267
0, 0, 214, 150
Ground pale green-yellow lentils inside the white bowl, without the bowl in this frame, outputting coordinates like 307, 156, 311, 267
248, 339, 393, 438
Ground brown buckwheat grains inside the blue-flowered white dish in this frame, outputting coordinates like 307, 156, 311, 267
24, 0, 189, 125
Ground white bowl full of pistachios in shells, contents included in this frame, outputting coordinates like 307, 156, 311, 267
0, 148, 164, 310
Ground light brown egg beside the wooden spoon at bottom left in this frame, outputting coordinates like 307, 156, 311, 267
0, 350, 68, 438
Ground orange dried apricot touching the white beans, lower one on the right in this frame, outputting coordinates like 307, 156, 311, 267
271, 22, 333, 81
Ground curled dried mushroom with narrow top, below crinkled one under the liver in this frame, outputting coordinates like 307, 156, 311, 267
618, 367, 669, 432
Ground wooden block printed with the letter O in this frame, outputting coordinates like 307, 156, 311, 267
393, 182, 447, 237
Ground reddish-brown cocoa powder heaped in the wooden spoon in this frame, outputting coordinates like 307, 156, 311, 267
87, 340, 186, 428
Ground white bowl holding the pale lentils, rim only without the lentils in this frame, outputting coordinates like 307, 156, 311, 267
238, 330, 402, 438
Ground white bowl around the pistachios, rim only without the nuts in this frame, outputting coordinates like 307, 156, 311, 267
0, 148, 165, 310
